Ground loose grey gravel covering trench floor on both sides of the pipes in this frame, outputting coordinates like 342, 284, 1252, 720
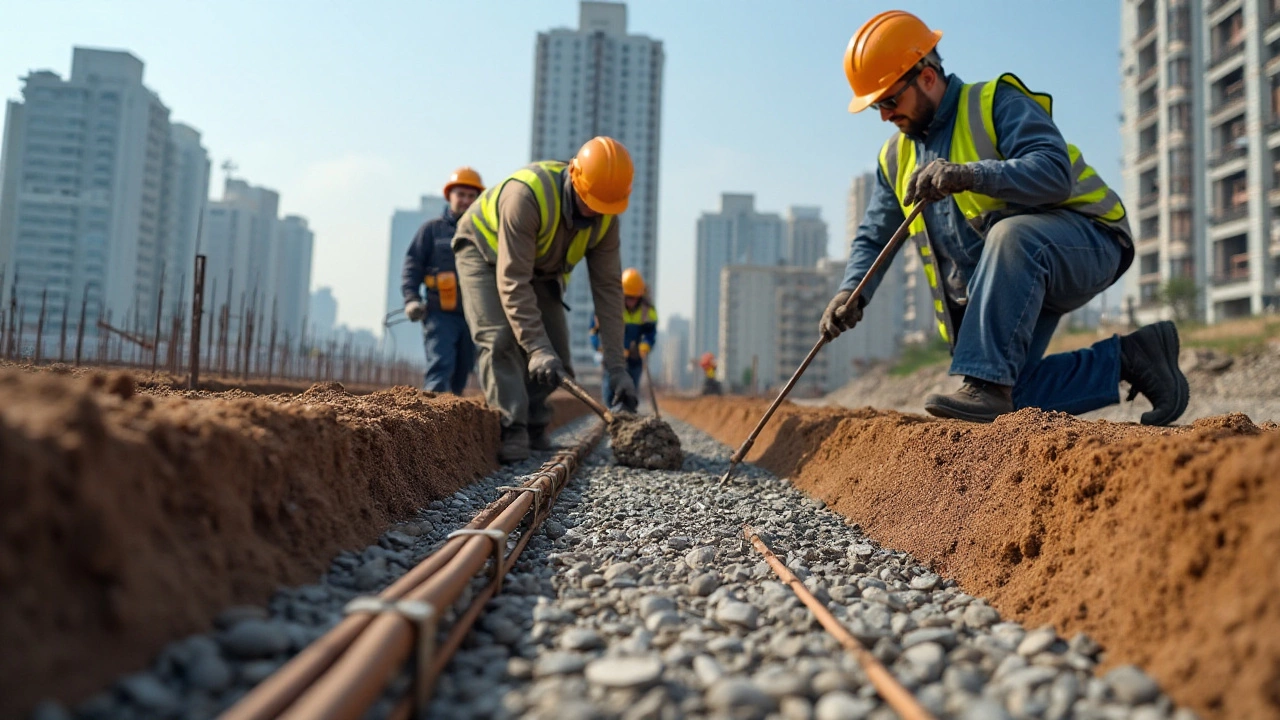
33, 419, 1196, 720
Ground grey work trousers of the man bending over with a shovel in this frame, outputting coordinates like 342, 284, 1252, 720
453, 242, 573, 430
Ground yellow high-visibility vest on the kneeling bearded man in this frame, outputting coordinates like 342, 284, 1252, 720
879, 73, 1133, 350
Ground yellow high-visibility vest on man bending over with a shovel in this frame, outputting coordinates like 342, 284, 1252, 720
471, 160, 613, 281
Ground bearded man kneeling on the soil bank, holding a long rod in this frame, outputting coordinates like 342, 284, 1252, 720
820, 10, 1188, 425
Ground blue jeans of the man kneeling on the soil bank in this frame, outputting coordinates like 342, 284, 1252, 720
951, 210, 1123, 415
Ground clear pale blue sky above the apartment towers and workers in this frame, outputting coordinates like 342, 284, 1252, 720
0, 0, 1120, 328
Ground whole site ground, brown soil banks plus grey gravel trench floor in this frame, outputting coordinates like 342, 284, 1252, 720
0, 343, 1280, 720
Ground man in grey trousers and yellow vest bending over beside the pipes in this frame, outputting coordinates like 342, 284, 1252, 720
453, 137, 637, 462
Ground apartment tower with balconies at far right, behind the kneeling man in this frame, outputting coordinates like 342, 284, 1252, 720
1120, 0, 1280, 323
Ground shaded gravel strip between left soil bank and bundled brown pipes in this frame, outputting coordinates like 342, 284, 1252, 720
31, 418, 599, 720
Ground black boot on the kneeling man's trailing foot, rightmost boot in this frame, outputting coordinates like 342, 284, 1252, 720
1120, 320, 1190, 425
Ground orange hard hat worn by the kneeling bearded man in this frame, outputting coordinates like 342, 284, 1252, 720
845, 10, 942, 113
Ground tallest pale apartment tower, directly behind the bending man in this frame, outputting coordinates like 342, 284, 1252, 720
530, 3, 664, 372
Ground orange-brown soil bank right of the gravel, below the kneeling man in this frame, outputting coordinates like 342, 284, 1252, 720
663, 398, 1280, 719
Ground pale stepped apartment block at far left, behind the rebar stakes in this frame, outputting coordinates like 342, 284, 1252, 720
0, 47, 207, 340
